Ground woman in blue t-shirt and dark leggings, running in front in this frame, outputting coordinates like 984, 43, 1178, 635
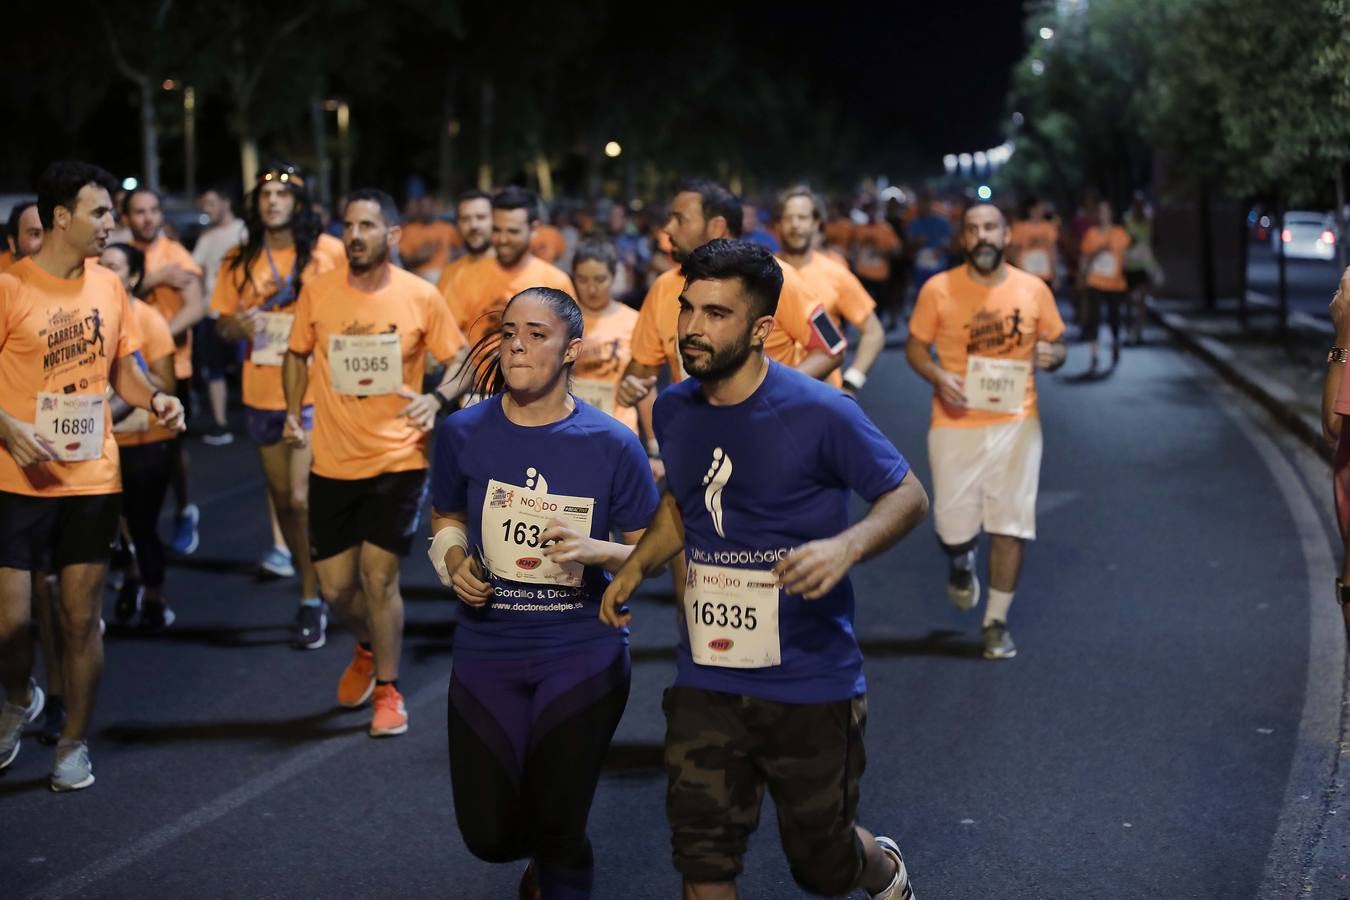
431, 287, 657, 899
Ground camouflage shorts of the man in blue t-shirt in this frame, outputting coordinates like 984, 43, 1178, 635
663, 687, 867, 895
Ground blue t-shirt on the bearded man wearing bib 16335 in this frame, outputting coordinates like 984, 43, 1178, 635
655, 362, 910, 703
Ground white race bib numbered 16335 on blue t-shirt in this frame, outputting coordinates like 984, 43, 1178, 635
684, 561, 783, 669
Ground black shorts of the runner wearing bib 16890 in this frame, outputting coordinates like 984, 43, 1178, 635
0, 491, 122, 572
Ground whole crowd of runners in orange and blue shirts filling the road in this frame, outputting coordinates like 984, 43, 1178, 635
0, 162, 1157, 899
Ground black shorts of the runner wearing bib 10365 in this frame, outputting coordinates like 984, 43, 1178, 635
309, 468, 427, 560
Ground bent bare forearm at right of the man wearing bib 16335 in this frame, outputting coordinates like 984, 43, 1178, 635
774, 471, 929, 600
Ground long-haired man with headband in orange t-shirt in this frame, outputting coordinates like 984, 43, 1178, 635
211, 166, 337, 650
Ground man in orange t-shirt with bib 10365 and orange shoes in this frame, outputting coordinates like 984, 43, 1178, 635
282, 190, 464, 737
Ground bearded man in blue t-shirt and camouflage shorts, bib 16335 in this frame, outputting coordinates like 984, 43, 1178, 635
601, 240, 927, 900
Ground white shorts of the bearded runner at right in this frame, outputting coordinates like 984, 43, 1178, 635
929, 417, 1041, 546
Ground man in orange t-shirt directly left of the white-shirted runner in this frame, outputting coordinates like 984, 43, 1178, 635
123, 188, 207, 555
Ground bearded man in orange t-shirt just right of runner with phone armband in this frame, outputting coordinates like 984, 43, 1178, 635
778, 188, 886, 395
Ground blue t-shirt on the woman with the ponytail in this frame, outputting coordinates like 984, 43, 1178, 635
431, 397, 657, 658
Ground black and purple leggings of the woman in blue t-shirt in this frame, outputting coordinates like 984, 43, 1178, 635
448, 642, 632, 900
